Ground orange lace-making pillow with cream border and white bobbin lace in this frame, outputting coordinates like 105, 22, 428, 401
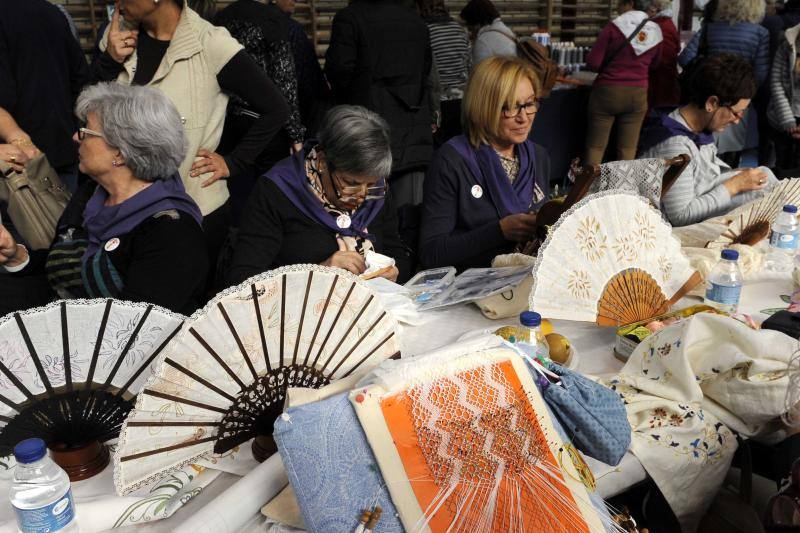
350, 348, 618, 533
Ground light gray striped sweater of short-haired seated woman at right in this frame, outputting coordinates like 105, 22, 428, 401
639, 109, 778, 226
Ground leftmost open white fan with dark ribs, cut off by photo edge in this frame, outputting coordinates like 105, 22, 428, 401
0, 300, 185, 481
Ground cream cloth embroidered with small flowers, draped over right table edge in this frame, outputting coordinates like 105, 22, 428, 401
605, 314, 798, 532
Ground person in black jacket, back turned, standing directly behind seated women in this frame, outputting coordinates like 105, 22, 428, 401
325, 0, 433, 207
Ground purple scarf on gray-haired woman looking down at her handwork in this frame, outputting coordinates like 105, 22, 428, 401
265, 141, 384, 240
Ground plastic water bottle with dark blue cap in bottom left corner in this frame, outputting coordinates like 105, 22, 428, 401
9, 439, 78, 533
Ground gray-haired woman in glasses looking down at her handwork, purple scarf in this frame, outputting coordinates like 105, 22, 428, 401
228, 105, 409, 283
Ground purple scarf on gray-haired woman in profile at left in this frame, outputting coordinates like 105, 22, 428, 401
83, 174, 203, 261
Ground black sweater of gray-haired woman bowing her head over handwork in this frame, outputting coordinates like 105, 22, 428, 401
228, 177, 410, 285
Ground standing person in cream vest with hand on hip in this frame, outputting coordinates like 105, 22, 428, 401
91, 0, 288, 282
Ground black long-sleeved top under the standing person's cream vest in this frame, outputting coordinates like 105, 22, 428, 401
90, 45, 288, 176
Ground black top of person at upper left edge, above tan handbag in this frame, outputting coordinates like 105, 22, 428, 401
0, 0, 89, 169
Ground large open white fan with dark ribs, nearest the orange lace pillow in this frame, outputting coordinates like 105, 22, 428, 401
114, 265, 398, 493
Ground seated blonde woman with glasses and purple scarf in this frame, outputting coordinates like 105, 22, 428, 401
420, 56, 550, 270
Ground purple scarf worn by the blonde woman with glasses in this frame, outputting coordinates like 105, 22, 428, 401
447, 135, 549, 218
